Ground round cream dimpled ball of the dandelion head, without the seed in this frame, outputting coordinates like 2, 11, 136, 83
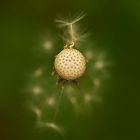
54, 48, 86, 80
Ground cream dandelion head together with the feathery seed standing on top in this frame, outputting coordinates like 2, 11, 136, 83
54, 14, 86, 81
